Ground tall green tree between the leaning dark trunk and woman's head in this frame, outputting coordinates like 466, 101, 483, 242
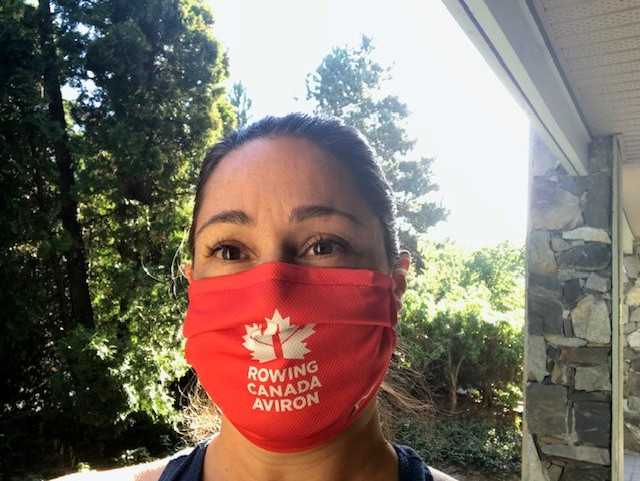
72, 0, 232, 428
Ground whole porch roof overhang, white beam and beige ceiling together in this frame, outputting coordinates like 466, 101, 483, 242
442, 0, 640, 240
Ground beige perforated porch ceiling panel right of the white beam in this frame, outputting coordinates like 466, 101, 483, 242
532, 0, 640, 166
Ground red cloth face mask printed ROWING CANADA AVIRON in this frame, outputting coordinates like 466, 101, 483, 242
184, 262, 396, 452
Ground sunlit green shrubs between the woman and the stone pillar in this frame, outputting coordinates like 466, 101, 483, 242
398, 243, 524, 412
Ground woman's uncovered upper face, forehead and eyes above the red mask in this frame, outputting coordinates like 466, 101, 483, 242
187, 137, 391, 280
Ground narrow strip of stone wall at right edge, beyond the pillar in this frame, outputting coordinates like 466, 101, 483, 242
622, 252, 640, 453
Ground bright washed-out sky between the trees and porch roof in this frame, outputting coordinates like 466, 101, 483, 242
211, 0, 529, 248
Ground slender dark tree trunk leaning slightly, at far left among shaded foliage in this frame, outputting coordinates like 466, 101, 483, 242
38, 0, 93, 326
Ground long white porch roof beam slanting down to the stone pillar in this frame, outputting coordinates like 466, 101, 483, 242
443, 0, 588, 175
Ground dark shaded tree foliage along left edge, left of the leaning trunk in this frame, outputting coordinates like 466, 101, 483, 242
0, 0, 72, 468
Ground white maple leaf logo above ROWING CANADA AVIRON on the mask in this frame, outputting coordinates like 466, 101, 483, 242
242, 309, 316, 362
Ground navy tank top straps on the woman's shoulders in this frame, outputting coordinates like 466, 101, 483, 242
158, 442, 433, 481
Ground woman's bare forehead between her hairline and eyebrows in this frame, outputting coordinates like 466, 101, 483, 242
202, 137, 373, 214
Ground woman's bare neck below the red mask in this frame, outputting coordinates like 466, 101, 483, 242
202, 402, 398, 481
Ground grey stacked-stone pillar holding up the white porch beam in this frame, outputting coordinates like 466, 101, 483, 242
525, 135, 613, 481
